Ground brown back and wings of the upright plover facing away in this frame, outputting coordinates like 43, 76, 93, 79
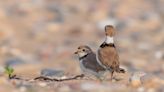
98, 47, 119, 69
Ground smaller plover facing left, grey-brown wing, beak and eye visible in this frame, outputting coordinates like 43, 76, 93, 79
75, 46, 106, 80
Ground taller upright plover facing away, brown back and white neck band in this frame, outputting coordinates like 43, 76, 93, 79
96, 25, 125, 79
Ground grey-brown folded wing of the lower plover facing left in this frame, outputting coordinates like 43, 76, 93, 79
83, 53, 105, 72
